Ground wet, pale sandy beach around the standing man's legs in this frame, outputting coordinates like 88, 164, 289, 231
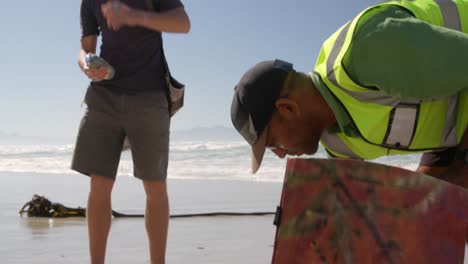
0, 173, 281, 264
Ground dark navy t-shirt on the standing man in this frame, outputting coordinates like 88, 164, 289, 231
81, 0, 183, 93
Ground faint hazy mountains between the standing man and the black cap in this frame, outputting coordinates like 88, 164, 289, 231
171, 126, 243, 141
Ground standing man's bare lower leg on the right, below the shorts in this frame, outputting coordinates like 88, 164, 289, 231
143, 181, 169, 264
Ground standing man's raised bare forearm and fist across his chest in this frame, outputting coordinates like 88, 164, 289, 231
101, 1, 190, 33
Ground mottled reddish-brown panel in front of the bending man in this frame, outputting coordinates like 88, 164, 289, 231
272, 159, 468, 264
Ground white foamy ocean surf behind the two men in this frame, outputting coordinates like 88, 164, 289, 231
0, 141, 420, 182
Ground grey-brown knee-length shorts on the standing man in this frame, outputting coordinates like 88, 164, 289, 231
71, 86, 170, 181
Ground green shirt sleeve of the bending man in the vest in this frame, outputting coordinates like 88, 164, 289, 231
343, 7, 468, 99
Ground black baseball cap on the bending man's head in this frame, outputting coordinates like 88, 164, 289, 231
231, 60, 294, 173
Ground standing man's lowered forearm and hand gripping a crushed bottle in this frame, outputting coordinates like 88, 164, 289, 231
78, 35, 109, 81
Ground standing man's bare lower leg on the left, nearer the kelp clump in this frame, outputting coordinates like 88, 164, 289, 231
86, 175, 114, 264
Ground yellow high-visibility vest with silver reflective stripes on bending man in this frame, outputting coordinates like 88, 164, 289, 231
315, 0, 468, 159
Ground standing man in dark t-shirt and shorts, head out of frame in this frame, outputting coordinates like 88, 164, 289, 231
72, 0, 190, 263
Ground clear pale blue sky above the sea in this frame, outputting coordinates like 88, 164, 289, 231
0, 0, 380, 138
